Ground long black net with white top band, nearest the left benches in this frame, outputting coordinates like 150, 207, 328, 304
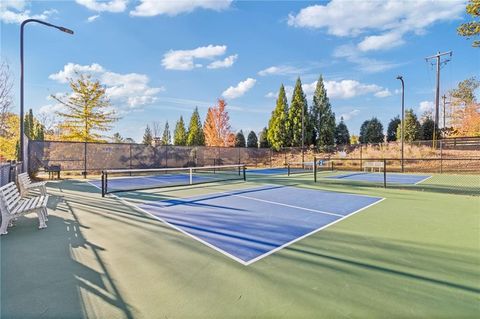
101, 164, 246, 196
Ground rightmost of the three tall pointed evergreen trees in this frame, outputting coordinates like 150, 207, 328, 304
311, 76, 335, 149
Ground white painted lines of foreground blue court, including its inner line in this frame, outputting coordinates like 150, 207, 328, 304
88, 181, 385, 266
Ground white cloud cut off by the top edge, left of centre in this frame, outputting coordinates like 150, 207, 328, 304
130, 0, 232, 17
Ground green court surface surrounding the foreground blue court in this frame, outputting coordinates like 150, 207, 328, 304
0, 175, 480, 318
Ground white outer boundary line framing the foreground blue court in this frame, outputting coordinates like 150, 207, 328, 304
87, 181, 386, 266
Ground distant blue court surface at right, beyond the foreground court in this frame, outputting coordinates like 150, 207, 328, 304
327, 172, 431, 185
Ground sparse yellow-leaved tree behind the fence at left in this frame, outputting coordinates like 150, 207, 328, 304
52, 75, 118, 142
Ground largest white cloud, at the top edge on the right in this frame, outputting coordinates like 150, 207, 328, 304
288, 0, 465, 51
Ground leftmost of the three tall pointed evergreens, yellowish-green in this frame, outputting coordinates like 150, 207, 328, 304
264, 84, 290, 150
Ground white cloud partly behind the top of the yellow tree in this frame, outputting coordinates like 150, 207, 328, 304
49, 63, 165, 109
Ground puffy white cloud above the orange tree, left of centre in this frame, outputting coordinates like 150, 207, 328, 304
162, 44, 228, 71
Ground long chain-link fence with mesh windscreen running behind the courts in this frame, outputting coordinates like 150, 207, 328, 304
28, 138, 480, 178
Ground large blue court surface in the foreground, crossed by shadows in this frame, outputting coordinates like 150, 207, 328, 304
138, 185, 382, 265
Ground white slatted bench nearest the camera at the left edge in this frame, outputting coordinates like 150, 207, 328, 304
0, 182, 48, 235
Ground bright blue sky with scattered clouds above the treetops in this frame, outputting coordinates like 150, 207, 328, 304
0, 0, 480, 141
